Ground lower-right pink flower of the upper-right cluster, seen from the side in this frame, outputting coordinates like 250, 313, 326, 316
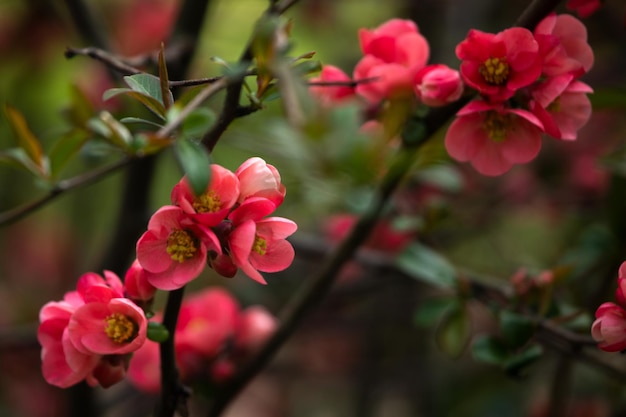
530, 74, 593, 140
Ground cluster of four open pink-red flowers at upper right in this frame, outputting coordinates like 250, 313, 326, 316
445, 13, 594, 176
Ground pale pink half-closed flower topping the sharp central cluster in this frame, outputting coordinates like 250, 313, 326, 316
235, 157, 286, 207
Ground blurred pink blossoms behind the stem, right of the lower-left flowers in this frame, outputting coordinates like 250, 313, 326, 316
128, 288, 277, 393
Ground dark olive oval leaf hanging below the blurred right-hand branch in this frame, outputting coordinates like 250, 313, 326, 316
435, 305, 471, 358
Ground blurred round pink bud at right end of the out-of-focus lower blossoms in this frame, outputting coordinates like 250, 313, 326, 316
235, 306, 278, 353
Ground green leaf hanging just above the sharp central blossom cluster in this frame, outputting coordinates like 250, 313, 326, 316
174, 136, 211, 195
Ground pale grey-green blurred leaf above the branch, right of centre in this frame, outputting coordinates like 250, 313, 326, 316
396, 242, 456, 287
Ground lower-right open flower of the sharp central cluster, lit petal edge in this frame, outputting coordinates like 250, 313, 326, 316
228, 213, 297, 284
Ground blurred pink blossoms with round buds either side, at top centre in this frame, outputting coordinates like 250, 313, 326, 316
311, 19, 463, 107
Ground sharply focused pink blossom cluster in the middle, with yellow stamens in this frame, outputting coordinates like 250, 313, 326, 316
137, 157, 297, 290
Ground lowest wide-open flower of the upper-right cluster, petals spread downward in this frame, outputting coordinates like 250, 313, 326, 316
445, 100, 543, 176
